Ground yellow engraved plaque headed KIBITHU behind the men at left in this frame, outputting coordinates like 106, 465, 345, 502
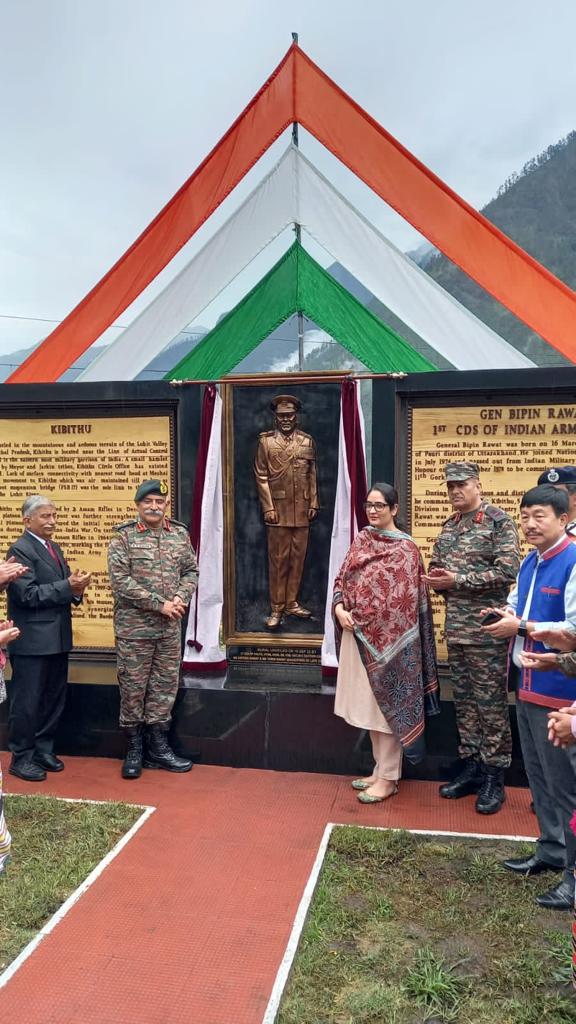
0, 416, 174, 650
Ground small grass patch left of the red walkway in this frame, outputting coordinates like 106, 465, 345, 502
0, 796, 142, 971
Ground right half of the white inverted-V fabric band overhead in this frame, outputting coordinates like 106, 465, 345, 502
298, 155, 534, 370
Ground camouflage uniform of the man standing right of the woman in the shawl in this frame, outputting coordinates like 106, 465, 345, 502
429, 501, 521, 768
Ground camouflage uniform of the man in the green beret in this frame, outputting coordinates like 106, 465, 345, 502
109, 519, 198, 727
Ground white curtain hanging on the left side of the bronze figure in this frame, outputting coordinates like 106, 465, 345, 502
182, 394, 227, 671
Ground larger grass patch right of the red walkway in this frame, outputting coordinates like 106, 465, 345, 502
277, 826, 576, 1024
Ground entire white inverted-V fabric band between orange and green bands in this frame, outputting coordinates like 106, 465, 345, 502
78, 146, 534, 381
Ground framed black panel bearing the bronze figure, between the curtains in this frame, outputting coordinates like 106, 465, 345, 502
222, 377, 340, 647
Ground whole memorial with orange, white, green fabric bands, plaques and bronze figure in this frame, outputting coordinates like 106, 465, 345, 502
0, 41, 576, 781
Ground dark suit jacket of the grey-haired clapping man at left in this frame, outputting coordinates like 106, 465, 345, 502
6, 532, 81, 655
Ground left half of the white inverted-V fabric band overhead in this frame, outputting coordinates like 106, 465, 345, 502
77, 147, 297, 381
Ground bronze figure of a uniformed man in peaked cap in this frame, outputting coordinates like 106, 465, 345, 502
254, 394, 319, 630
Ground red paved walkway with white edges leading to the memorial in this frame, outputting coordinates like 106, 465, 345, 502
0, 758, 535, 1024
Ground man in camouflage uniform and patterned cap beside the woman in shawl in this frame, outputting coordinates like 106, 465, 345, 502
426, 462, 520, 814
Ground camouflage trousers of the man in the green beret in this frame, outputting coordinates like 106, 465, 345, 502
116, 630, 180, 726
